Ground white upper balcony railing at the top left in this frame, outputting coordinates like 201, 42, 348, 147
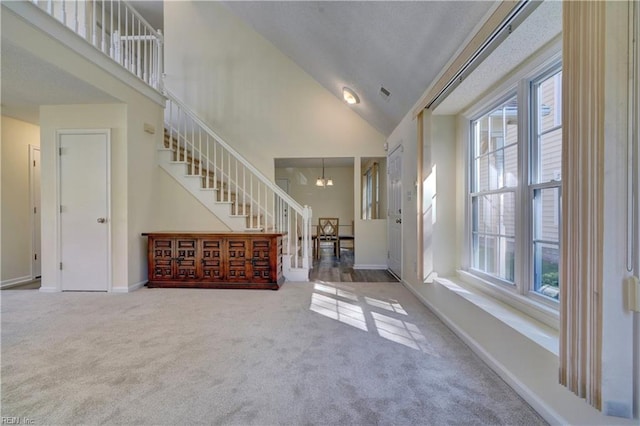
31, 0, 163, 92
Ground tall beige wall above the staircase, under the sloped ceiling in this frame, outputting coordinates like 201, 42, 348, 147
164, 2, 385, 177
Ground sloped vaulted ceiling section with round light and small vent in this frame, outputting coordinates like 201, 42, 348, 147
220, 1, 493, 135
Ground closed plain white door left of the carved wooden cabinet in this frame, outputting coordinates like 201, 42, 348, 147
59, 130, 110, 291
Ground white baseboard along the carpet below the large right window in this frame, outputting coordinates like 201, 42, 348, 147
401, 280, 569, 425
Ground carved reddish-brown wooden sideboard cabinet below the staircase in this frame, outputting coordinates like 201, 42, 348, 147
142, 232, 284, 290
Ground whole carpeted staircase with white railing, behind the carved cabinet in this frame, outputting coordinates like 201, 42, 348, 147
158, 91, 312, 281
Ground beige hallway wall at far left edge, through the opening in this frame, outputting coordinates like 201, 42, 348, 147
0, 116, 40, 285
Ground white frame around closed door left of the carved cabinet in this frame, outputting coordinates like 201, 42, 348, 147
55, 129, 113, 292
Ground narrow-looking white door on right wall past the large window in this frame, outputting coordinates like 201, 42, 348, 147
387, 145, 402, 277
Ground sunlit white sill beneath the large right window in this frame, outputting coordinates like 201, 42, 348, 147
434, 271, 559, 356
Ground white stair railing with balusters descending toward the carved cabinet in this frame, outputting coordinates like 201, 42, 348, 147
165, 89, 312, 269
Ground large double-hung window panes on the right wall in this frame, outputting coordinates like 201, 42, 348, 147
468, 65, 562, 304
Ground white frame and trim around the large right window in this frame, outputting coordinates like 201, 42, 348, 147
458, 37, 562, 329
